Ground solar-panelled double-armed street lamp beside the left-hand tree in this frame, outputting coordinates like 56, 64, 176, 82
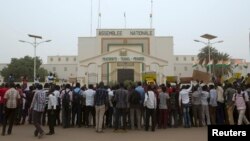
19, 34, 51, 82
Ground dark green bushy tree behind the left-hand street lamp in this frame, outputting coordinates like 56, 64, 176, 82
0, 56, 48, 82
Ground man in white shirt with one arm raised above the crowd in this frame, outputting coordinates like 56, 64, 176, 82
179, 81, 193, 128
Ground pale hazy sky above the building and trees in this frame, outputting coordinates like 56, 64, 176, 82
0, 0, 250, 63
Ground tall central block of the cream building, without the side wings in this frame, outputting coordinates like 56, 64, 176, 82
77, 29, 174, 84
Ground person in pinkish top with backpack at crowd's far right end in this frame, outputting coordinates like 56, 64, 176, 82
232, 86, 250, 125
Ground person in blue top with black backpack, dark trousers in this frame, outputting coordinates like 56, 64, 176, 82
71, 83, 83, 127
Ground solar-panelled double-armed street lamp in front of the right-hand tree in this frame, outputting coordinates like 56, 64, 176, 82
194, 34, 223, 74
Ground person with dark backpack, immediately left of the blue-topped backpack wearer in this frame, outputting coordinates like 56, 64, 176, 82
61, 84, 72, 128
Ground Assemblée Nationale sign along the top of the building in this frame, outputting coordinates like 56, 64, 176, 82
96, 29, 154, 36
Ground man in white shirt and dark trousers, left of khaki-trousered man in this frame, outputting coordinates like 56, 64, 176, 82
83, 84, 95, 127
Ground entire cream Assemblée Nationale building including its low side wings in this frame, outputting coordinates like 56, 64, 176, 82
0, 28, 250, 85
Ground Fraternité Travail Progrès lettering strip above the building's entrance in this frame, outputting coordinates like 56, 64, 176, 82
102, 57, 144, 62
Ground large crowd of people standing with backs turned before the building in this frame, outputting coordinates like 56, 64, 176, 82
0, 78, 250, 138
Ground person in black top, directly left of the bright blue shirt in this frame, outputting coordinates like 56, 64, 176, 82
128, 86, 141, 129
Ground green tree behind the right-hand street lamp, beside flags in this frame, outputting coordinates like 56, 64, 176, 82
197, 46, 233, 77
